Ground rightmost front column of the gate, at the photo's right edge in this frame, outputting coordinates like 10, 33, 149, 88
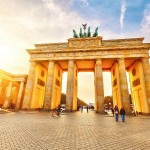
141, 58, 150, 113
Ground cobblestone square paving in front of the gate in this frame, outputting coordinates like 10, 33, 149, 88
0, 111, 150, 150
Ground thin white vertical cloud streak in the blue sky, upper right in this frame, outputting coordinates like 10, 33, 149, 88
120, 0, 126, 29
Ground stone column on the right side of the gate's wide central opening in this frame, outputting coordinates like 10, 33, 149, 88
95, 60, 104, 113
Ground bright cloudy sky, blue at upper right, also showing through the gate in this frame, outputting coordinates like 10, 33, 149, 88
0, 0, 150, 101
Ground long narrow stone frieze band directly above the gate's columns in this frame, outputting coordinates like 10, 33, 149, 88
31, 49, 147, 60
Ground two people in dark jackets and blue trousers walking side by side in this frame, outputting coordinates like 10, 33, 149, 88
112, 105, 126, 122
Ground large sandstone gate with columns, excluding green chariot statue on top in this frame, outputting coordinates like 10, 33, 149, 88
22, 26, 150, 114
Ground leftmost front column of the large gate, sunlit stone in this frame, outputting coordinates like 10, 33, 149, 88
22, 62, 36, 109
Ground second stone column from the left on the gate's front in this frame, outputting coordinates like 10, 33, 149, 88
43, 61, 55, 109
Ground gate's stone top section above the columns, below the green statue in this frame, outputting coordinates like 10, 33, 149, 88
27, 37, 150, 61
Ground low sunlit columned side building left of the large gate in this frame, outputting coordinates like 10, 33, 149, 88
0, 70, 27, 109
